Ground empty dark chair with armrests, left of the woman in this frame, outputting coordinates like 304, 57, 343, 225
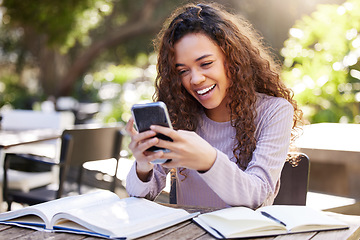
3, 126, 122, 210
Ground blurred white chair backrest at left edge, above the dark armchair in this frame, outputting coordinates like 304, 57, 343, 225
1, 109, 75, 130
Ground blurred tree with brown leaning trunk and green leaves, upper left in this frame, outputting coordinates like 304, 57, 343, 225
1, 0, 183, 97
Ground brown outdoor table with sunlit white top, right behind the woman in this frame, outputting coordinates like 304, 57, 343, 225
296, 123, 360, 200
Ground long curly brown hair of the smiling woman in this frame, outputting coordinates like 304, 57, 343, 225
153, 4, 302, 167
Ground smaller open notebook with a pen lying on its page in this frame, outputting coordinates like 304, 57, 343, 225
194, 205, 348, 238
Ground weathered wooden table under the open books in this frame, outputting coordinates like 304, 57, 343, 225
0, 204, 360, 240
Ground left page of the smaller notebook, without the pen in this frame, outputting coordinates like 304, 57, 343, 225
198, 207, 286, 238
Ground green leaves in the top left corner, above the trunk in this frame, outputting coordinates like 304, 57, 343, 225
2, 0, 112, 51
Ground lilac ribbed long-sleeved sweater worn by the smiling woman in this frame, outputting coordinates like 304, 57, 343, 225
126, 94, 293, 208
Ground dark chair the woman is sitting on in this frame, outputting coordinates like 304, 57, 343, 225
169, 152, 310, 205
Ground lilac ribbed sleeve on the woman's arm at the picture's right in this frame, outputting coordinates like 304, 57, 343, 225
200, 95, 293, 208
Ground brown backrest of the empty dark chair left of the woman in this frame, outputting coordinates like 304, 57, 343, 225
58, 126, 122, 196
